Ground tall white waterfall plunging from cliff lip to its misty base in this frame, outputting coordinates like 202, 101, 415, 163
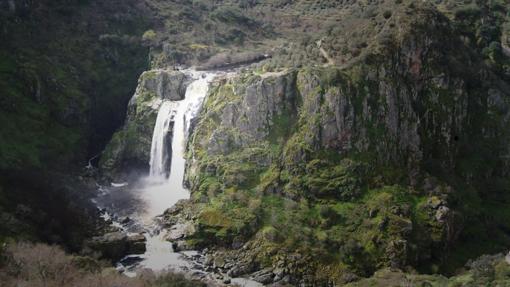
141, 71, 215, 219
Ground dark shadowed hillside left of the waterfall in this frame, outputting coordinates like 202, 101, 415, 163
0, 0, 150, 249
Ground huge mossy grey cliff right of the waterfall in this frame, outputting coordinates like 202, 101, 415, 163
166, 5, 510, 284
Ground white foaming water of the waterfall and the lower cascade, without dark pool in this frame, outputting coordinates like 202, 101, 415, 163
120, 72, 219, 275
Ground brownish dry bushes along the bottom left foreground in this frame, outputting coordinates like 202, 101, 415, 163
0, 243, 205, 287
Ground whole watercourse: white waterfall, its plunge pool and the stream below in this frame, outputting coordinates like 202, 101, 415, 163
91, 71, 262, 286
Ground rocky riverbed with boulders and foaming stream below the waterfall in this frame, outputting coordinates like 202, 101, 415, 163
86, 181, 264, 286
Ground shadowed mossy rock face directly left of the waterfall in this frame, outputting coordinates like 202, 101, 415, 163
100, 70, 188, 179
